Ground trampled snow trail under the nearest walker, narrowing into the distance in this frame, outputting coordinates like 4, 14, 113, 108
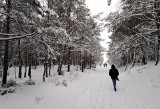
70, 67, 150, 109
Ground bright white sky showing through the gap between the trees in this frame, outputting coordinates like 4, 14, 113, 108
86, 0, 121, 49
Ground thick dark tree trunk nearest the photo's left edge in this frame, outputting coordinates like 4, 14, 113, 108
2, 0, 11, 86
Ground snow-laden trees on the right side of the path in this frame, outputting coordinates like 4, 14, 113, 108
104, 0, 160, 68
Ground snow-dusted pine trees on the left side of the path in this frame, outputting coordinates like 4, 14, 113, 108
0, 0, 104, 87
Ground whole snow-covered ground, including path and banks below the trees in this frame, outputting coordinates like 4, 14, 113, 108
0, 63, 160, 109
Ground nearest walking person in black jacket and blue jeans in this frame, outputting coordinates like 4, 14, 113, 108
109, 65, 119, 91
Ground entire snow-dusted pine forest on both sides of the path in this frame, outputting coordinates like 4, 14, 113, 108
0, 0, 160, 86
